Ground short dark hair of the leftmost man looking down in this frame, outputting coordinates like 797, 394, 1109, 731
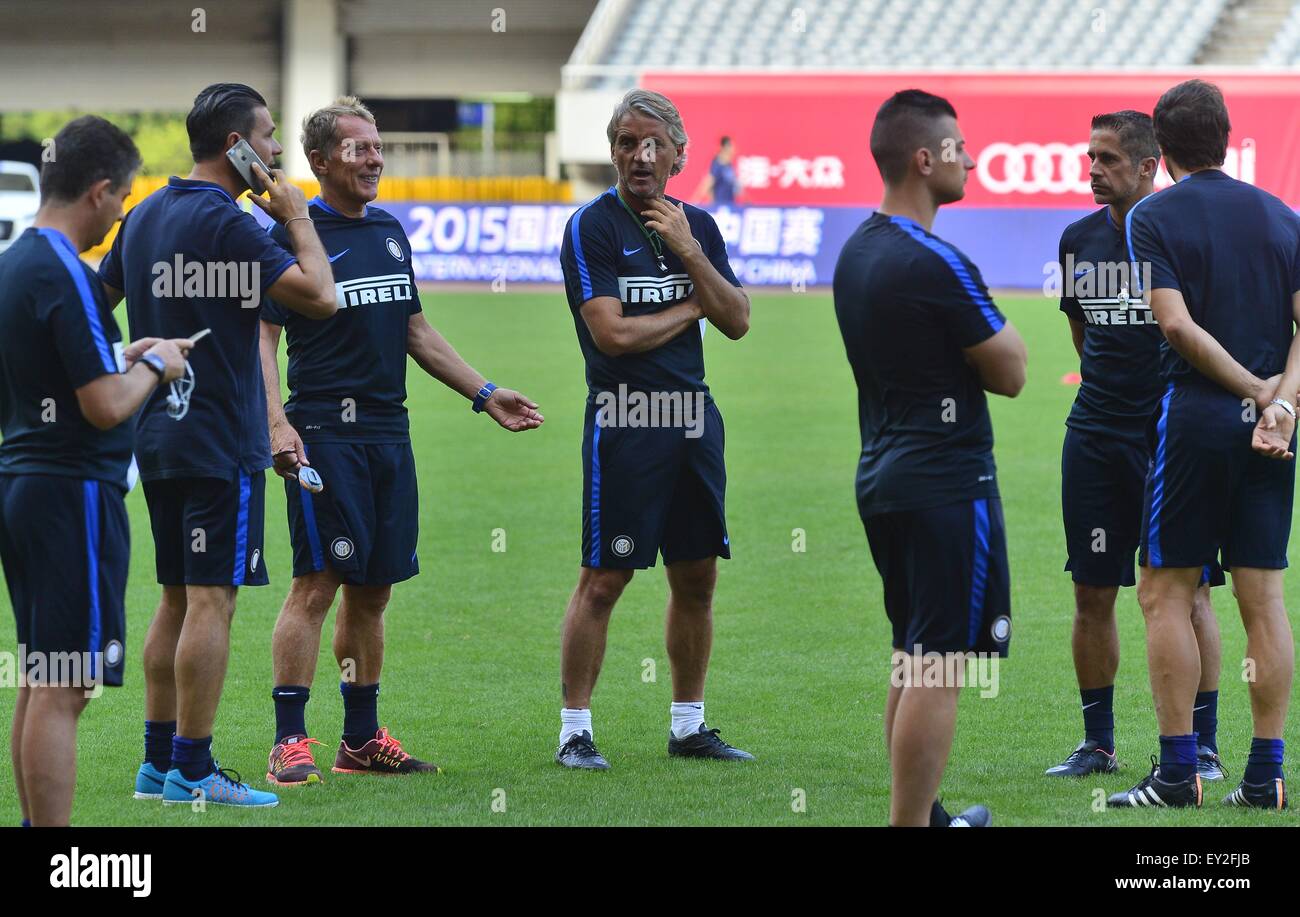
40, 114, 140, 203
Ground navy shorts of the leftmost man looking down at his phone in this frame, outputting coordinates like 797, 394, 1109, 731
0, 475, 131, 687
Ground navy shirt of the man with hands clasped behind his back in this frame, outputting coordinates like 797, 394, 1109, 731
1126, 169, 1300, 388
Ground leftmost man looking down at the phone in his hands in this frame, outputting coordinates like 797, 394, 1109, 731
0, 116, 190, 827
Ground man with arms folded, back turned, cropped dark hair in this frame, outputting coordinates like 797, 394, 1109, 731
835, 90, 1026, 827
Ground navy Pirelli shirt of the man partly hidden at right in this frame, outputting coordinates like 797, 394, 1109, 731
1060, 207, 1165, 445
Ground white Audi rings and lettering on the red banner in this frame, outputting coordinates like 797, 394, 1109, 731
975, 138, 1255, 194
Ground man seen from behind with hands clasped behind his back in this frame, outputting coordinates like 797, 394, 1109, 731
1108, 79, 1300, 809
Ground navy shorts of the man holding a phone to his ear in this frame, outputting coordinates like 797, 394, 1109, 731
144, 471, 269, 585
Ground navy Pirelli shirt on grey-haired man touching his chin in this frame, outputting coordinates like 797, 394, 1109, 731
560, 187, 740, 398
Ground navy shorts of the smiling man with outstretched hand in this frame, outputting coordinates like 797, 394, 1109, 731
285, 442, 420, 585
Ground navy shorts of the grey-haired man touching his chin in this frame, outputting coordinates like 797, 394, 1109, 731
582, 401, 731, 570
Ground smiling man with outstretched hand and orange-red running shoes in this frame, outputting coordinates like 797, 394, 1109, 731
261, 96, 542, 786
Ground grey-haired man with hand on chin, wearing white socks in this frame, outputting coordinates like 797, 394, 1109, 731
555, 90, 753, 769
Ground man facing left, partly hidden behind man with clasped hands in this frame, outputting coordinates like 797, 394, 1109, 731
1047, 111, 1223, 780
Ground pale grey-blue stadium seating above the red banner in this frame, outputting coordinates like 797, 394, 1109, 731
571, 0, 1227, 87
